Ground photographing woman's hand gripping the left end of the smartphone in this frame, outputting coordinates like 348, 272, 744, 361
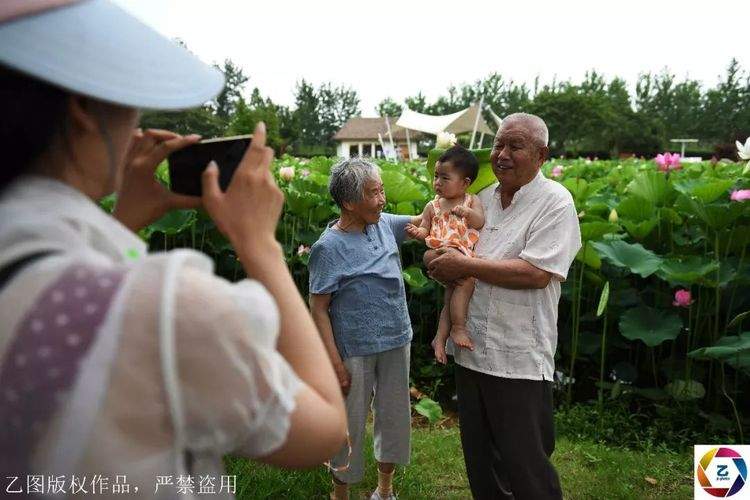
113, 130, 201, 232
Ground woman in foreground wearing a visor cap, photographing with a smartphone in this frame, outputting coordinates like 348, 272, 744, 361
0, 0, 346, 497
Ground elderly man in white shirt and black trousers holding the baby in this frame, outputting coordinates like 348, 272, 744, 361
425, 113, 581, 500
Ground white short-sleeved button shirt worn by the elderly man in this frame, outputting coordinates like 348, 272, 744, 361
448, 171, 581, 380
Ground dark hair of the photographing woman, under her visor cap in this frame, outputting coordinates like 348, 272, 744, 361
0, 66, 70, 192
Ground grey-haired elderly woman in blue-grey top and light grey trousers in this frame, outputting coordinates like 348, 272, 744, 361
309, 158, 420, 499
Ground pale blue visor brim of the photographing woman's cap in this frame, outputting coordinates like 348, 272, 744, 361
0, 0, 224, 110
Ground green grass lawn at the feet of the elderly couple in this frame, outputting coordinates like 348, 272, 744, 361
227, 427, 693, 500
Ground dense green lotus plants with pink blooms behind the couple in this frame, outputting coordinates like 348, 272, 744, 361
116, 150, 750, 442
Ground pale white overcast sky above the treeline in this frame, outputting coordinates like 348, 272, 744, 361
115, 0, 750, 116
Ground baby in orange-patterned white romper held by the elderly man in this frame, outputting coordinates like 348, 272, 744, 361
406, 146, 484, 364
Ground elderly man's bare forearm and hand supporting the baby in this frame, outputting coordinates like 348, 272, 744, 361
427, 251, 552, 290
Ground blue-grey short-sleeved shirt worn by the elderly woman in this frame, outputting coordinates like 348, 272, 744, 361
308, 213, 412, 359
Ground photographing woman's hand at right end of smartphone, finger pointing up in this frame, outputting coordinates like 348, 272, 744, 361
203, 122, 284, 266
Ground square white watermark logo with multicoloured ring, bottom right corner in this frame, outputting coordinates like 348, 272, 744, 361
694, 445, 750, 500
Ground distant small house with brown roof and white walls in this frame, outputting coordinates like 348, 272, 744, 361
333, 116, 424, 158
